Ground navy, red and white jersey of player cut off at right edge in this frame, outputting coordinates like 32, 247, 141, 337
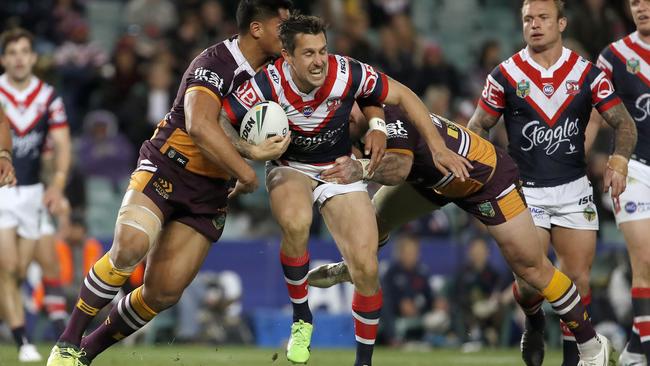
598, 32, 650, 165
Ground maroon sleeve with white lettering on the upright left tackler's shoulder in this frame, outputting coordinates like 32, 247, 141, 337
185, 49, 233, 101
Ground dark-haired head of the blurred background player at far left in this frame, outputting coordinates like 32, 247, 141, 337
0, 28, 37, 82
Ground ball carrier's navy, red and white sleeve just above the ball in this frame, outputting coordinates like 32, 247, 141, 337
222, 68, 277, 128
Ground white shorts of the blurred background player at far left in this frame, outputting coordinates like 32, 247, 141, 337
0, 183, 47, 239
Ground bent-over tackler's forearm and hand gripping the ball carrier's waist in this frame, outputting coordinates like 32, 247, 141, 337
320, 151, 413, 186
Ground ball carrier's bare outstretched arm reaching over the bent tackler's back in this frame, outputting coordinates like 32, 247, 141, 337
384, 78, 472, 182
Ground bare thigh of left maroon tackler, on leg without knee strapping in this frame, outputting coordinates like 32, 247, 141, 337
144, 221, 211, 297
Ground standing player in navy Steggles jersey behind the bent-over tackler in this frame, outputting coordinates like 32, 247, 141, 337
468, 0, 636, 366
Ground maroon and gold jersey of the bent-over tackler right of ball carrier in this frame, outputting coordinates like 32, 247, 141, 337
384, 107, 526, 225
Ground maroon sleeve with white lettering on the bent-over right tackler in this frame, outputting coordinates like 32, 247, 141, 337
384, 106, 419, 156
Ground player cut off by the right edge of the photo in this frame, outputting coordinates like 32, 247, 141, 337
598, 0, 650, 366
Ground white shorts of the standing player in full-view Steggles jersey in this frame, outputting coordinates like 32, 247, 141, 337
523, 176, 598, 230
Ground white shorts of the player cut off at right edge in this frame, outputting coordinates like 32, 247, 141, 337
613, 160, 650, 225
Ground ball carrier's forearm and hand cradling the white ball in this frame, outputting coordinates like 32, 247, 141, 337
219, 109, 291, 161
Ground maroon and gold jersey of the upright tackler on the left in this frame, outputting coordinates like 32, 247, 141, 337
145, 36, 255, 179
